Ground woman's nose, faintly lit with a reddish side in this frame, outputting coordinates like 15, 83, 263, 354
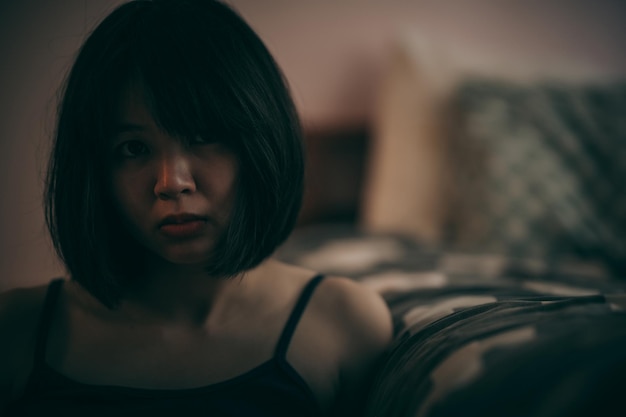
154, 153, 196, 199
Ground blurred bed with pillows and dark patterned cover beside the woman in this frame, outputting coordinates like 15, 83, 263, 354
277, 32, 626, 417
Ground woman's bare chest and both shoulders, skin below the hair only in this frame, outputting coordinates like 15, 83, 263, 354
0, 260, 391, 412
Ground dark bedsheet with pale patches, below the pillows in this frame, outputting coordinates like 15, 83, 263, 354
277, 225, 626, 416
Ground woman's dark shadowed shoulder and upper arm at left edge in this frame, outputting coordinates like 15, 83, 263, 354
0, 284, 55, 409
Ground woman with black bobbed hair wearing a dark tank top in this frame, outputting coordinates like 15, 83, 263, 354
0, 0, 391, 417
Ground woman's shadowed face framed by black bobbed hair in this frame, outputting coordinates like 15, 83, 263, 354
109, 90, 238, 264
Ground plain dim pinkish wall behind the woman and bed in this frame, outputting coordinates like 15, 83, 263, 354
0, 0, 626, 290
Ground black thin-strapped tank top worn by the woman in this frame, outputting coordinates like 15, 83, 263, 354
8, 275, 323, 417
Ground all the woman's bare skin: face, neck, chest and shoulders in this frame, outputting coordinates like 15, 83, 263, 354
0, 90, 391, 415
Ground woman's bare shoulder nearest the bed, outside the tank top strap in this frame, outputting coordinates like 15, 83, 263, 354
292, 276, 393, 415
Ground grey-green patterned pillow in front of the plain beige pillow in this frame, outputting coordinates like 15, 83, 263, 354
448, 80, 626, 271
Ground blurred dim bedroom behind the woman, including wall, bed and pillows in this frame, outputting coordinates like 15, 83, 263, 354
0, 0, 626, 417
